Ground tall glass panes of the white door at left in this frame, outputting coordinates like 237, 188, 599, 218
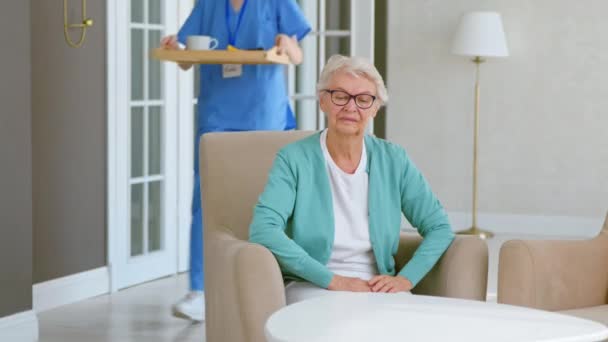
129, 0, 166, 257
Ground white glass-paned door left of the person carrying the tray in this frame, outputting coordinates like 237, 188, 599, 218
108, 0, 179, 291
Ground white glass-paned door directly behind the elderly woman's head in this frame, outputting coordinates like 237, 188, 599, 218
288, 0, 375, 132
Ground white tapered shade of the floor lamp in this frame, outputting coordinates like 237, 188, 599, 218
452, 12, 509, 57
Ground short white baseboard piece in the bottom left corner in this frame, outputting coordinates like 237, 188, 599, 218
0, 310, 38, 342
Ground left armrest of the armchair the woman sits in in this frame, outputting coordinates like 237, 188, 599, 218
204, 227, 285, 342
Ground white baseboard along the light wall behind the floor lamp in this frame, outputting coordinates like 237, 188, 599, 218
402, 211, 603, 238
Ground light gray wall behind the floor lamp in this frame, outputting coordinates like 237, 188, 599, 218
387, 0, 608, 219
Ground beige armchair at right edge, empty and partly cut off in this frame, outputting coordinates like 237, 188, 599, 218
498, 211, 608, 325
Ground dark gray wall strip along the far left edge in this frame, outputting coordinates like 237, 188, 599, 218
0, 1, 32, 317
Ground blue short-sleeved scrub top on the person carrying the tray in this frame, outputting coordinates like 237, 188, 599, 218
177, 0, 310, 133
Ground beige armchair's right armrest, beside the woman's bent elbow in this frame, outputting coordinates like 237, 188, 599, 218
395, 233, 488, 301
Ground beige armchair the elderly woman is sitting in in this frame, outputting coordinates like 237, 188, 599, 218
200, 131, 488, 342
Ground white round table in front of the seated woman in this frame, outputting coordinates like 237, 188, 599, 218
266, 292, 608, 342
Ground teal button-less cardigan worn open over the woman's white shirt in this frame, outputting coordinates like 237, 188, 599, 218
249, 133, 454, 288
